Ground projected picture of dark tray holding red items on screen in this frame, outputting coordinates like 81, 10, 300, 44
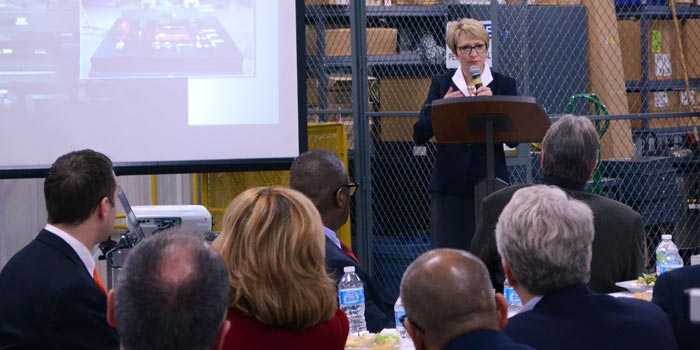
80, 0, 255, 78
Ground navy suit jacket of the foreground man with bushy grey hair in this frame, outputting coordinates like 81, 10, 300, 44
505, 285, 677, 350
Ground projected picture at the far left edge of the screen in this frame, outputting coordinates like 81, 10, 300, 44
0, 0, 79, 110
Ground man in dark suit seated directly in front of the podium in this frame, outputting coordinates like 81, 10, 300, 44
469, 115, 645, 293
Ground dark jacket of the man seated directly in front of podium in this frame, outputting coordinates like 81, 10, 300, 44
469, 178, 646, 293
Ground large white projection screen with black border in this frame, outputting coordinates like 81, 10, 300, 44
0, 0, 306, 178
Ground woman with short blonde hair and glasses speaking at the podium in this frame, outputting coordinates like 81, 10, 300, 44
413, 18, 518, 250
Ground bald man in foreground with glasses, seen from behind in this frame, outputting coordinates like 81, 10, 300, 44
401, 248, 532, 350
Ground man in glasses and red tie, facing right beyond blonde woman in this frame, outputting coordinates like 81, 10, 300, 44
289, 150, 395, 332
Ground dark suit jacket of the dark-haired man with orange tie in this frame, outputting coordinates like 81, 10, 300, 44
0, 230, 119, 350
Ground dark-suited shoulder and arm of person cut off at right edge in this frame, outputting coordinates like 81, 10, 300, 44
651, 265, 700, 350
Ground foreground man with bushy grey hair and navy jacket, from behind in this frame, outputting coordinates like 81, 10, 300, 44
496, 185, 677, 350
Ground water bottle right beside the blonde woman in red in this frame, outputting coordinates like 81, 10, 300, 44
338, 266, 367, 334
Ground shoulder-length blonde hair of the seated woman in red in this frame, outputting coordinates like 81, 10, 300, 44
213, 186, 338, 330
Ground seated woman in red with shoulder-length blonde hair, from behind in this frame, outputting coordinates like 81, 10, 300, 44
213, 187, 348, 350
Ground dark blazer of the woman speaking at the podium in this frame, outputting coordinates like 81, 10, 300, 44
413, 69, 518, 196
